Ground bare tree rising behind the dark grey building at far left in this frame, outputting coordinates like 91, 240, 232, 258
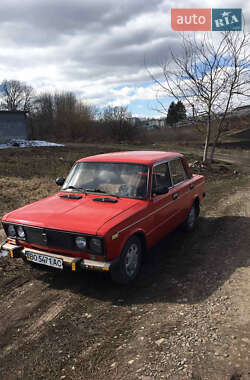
0, 80, 34, 113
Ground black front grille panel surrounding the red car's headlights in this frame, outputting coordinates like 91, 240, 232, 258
3, 223, 104, 256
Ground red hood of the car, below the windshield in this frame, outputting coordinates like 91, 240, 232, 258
2, 193, 139, 235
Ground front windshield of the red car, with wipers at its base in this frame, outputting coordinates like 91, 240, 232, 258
62, 162, 148, 199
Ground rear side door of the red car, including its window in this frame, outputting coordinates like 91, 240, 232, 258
169, 157, 192, 224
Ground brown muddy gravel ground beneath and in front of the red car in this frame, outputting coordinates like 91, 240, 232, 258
0, 147, 250, 380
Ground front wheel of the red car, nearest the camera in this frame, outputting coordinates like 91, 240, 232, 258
111, 236, 142, 284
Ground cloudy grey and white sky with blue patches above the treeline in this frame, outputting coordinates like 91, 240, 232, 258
0, 0, 250, 117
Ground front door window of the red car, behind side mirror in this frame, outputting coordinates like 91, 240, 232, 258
152, 163, 172, 195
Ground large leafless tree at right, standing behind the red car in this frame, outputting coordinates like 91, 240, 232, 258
150, 31, 250, 163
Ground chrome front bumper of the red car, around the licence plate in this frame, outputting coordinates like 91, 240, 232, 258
0, 241, 112, 272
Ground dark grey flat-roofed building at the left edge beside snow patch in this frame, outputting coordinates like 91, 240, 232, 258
0, 111, 28, 142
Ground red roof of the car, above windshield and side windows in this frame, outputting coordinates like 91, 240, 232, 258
77, 150, 183, 165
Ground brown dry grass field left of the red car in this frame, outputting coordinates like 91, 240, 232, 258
0, 144, 133, 216
